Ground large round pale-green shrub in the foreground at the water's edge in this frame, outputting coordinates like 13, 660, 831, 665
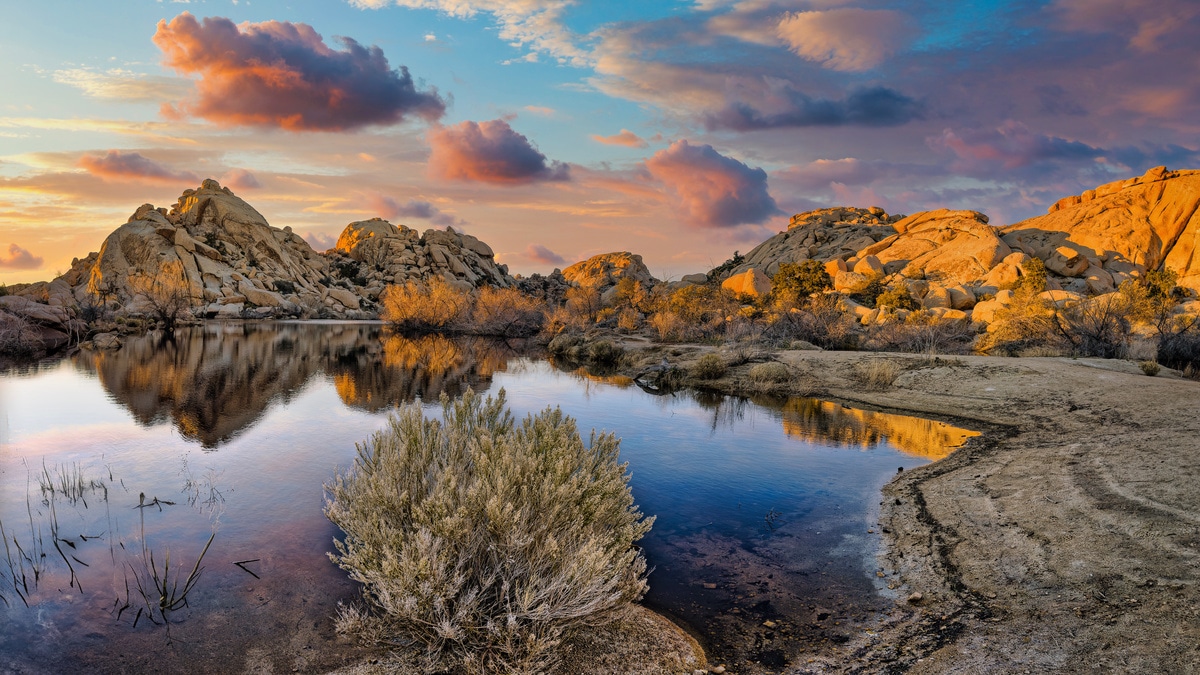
325, 390, 653, 674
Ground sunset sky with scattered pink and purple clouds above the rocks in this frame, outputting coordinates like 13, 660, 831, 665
0, 0, 1200, 283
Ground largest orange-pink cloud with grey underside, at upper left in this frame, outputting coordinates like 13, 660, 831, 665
154, 12, 445, 131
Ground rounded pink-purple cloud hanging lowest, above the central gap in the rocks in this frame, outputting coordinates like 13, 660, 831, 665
646, 141, 780, 227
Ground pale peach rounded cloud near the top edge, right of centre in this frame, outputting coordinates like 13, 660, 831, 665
776, 7, 914, 71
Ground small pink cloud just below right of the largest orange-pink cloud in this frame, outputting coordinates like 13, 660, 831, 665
428, 119, 570, 185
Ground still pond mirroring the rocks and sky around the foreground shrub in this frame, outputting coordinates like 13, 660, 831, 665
0, 323, 972, 673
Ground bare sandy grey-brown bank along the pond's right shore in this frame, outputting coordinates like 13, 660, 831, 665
628, 348, 1200, 674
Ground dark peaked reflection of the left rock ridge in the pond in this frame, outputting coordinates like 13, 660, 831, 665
74, 323, 525, 448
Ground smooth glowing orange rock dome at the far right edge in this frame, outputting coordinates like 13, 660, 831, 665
1002, 167, 1200, 294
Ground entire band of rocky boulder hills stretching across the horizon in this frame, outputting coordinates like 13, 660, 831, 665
7, 167, 1200, 345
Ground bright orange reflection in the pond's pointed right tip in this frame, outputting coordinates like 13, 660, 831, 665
782, 399, 979, 460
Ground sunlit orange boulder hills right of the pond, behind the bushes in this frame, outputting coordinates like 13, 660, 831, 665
708, 167, 1200, 323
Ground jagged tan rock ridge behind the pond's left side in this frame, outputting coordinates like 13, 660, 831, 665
22, 179, 514, 318
